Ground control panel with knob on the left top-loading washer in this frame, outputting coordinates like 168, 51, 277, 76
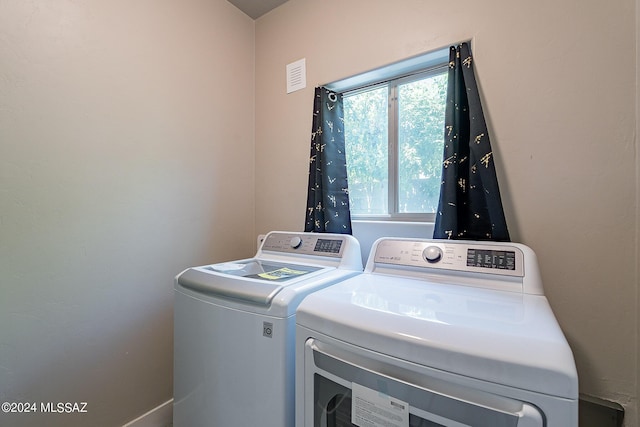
262, 232, 347, 258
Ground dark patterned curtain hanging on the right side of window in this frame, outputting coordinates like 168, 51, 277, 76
433, 43, 509, 241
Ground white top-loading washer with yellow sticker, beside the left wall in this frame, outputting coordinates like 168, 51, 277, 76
173, 232, 362, 427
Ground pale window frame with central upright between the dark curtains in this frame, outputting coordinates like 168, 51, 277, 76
332, 47, 449, 222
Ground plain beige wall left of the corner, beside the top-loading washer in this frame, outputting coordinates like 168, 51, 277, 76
0, 0, 255, 427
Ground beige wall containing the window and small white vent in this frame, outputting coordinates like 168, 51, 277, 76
256, 0, 638, 426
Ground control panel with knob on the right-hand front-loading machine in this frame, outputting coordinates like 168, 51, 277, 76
374, 239, 524, 277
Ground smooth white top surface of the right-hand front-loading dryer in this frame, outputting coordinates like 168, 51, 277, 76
296, 273, 578, 399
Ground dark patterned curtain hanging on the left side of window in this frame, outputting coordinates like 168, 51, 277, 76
305, 87, 351, 234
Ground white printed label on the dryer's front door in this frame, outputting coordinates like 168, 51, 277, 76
351, 383, 409, 427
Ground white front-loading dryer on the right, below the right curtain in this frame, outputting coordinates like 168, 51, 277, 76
296, 238, 578, 427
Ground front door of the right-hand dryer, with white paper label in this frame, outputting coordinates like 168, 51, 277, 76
304, 339, 545, 427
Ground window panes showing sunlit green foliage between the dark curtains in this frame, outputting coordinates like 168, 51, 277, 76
344, 66, 447, 220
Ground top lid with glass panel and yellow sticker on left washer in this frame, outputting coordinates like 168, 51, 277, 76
176, 259, 324, 305
